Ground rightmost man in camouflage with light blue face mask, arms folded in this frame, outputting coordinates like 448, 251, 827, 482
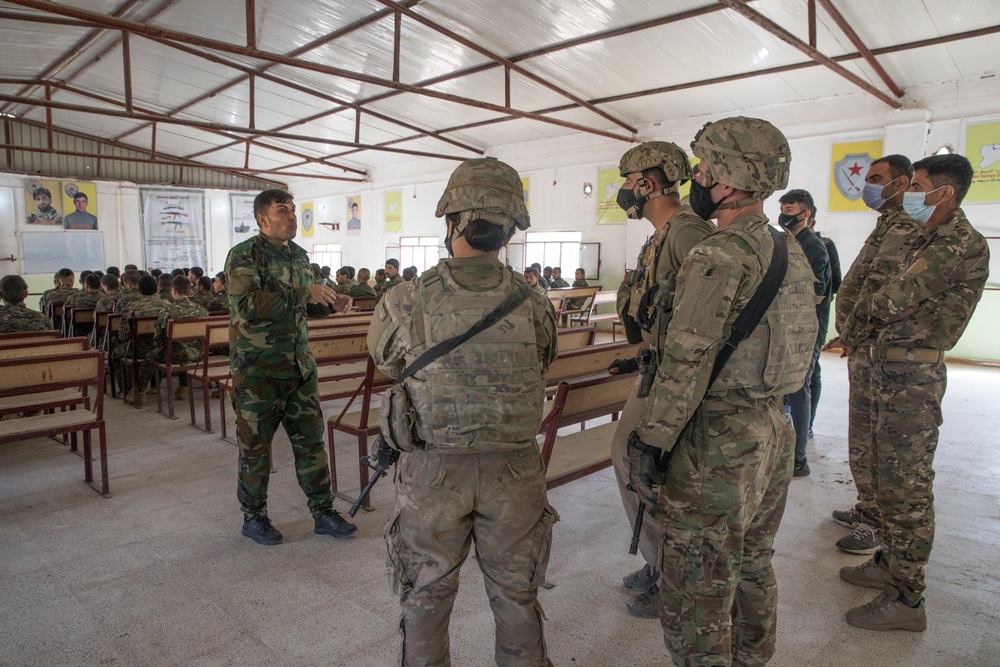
840, 154, 990, 632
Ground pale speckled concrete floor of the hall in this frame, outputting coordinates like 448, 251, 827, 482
0, 355, 1000, 667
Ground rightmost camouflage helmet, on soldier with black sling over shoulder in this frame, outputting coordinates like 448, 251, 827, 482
691, 116, 792, 199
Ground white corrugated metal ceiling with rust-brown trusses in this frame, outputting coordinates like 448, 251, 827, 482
0, 0, 1000, 187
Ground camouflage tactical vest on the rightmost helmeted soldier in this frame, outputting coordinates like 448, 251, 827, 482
710, 229, 819, 398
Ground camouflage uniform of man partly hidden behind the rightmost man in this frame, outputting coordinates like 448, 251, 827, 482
835, 206, 923, 533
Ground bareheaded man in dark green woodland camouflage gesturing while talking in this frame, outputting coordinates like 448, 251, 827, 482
226, 190, 356, 544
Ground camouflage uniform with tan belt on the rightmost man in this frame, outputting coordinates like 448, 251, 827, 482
854, 209, 989, 602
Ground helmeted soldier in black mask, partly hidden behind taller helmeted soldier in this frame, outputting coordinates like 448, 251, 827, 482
609, 141, 715, 618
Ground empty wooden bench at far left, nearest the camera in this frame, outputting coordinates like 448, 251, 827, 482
0, 350, 111, 497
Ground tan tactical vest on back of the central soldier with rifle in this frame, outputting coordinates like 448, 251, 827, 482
405, 263, 545, 450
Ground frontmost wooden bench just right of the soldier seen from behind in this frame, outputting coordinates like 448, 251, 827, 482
540, 373, 638, 489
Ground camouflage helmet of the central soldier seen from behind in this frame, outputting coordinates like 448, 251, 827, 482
434, 157, 531, 233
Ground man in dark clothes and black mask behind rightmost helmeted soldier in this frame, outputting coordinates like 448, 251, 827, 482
778, 190, 831, 477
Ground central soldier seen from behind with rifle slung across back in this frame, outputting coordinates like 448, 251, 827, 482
368, 158, 558, 667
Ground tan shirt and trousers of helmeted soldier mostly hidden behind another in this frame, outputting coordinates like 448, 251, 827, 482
611, 206, 715, 565
